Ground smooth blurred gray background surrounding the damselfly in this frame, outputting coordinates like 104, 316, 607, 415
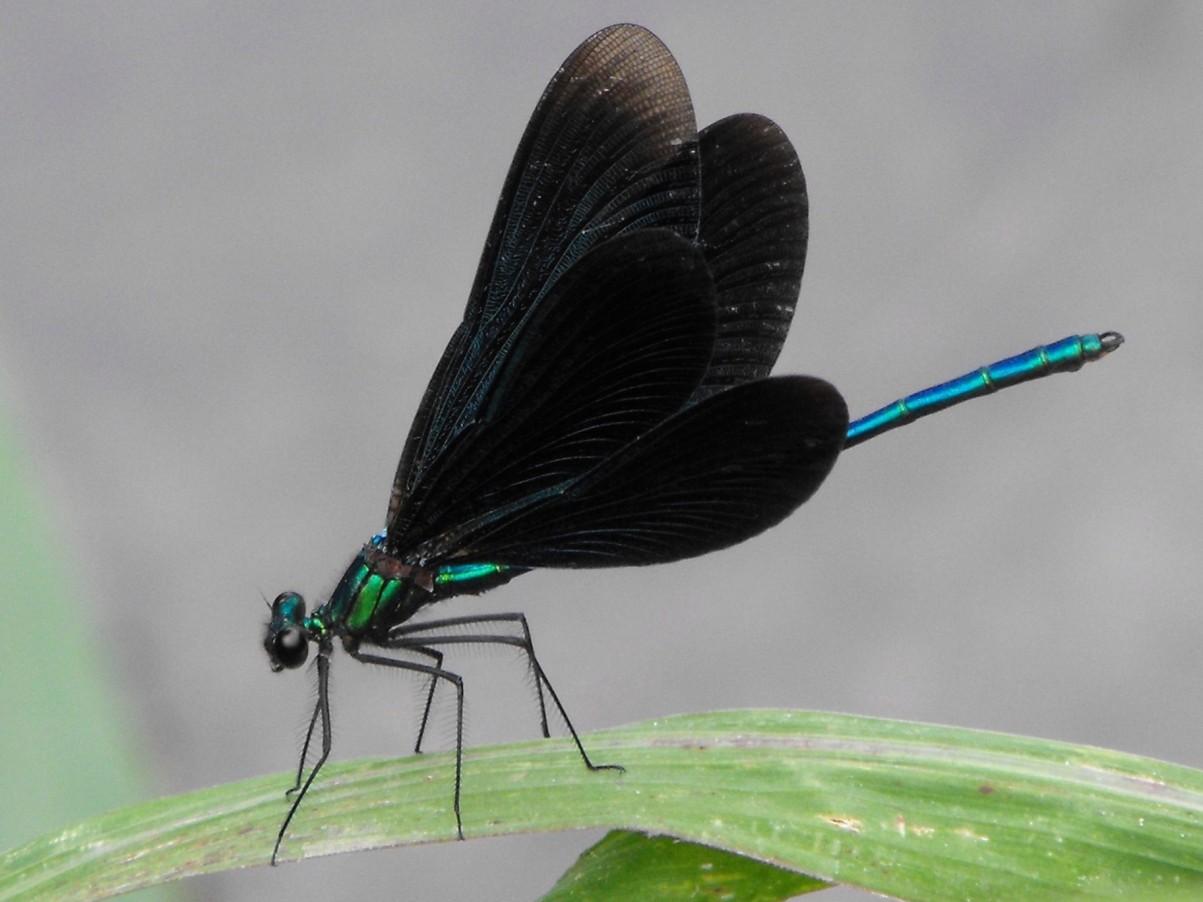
0, 2, 1203, 902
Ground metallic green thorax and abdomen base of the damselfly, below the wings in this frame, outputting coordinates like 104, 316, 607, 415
306, 535, 526, 636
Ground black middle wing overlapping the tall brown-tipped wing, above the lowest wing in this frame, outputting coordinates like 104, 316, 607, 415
387, 229, 715, 564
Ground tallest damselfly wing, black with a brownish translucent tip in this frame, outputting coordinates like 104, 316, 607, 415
387, 25, 700, 532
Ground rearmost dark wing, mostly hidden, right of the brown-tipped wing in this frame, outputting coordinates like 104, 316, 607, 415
694, 113, 808, 400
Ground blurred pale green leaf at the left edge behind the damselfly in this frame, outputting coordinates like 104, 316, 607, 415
0, 398, 178, 900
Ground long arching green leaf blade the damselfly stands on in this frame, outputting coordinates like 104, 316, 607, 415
0, 711, 1203, 900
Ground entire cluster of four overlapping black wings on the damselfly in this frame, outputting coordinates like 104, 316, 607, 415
386, 25, 847, 566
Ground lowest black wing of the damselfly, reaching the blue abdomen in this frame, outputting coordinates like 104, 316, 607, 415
428, 376, 848, 566
